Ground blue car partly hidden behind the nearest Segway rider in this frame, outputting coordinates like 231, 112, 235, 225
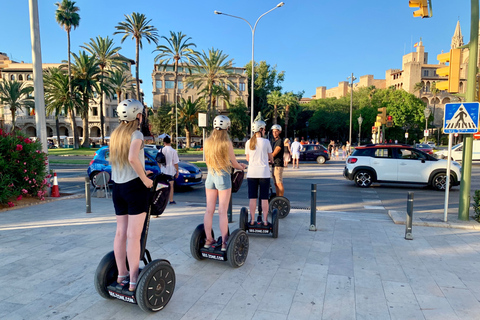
87, 147, 202, 187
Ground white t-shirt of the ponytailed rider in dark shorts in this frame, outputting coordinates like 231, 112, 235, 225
245, 138, 272, 178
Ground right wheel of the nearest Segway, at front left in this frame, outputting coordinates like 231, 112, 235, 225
135, 259, 175, 312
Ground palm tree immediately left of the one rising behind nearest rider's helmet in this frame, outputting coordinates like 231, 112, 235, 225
80, 36, 126, 145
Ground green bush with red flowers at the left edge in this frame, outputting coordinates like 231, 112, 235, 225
0, 129, 50, 207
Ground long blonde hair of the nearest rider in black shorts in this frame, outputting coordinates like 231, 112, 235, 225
110, 119, 139, 170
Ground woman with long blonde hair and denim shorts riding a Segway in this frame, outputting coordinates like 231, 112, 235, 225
203, 115, 247, 251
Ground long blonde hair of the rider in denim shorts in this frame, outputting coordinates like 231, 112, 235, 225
204, 130, 231, 174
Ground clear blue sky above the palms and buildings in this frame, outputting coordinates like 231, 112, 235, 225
0, 0, 470, 105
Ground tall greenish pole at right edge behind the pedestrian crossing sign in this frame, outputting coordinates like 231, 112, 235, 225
458, 0, 478, 220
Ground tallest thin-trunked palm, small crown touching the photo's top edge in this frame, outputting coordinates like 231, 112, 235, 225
55, 0, 80, 149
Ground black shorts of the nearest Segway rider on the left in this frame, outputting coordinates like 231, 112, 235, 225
112, 178, 149, 216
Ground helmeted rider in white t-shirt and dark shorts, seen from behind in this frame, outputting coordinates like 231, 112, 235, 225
245, 121, 273, 226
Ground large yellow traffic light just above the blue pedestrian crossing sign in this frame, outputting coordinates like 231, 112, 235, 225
435, 49, 462, 93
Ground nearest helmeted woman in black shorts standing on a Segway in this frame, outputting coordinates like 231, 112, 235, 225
110, 99, 153, 292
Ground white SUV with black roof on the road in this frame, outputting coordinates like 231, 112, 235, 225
343, 144, 461, 190
